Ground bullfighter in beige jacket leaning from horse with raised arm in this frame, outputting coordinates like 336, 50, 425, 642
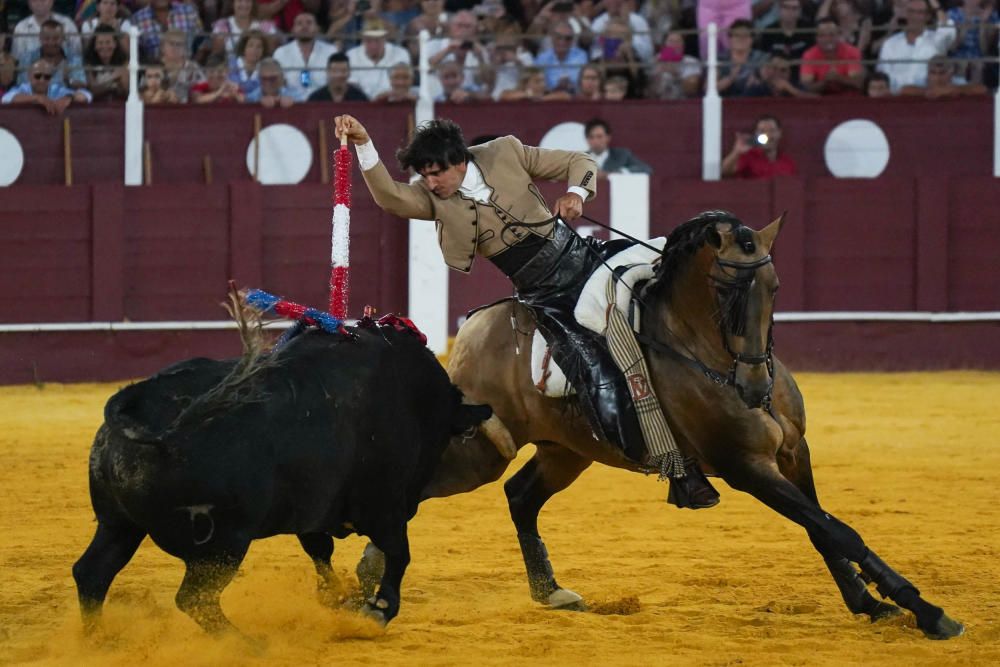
335, 115, 719, 509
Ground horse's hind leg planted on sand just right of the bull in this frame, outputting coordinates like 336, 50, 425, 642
504, 442, 591, 609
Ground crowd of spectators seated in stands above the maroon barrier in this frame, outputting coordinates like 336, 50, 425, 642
0, 0, 1000, 113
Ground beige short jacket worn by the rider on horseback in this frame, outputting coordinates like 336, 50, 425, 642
364, 136, 597, 272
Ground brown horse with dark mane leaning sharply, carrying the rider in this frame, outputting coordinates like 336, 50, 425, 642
358, 211, 964, 639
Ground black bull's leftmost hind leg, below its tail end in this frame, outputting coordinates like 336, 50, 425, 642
73, 522, 146, 633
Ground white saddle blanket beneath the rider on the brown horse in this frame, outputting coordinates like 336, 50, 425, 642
531, 236, 667, 398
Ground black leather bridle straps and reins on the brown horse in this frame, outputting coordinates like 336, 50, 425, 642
635, 255, 774, 416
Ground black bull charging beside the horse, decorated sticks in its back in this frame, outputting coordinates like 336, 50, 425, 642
73, 327, 490, 632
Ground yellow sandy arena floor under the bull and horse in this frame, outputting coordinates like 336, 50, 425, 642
0, 373, 1000, 667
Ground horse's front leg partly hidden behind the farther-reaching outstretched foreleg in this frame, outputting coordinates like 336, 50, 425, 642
778, 438, 902, 623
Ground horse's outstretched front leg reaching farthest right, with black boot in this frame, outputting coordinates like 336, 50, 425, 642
719, 457, 965, 639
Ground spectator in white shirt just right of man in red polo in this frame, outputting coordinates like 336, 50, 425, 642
876, 0, 957, 93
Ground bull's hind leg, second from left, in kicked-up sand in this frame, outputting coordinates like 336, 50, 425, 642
174, 540, 250, 634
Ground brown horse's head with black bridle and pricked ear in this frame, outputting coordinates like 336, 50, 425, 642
705, 215, 785, 408
